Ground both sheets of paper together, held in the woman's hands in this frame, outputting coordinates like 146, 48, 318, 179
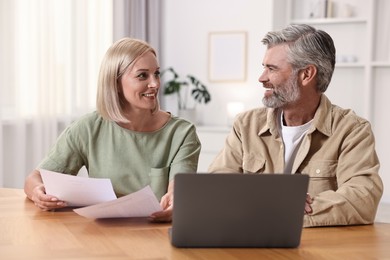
40, 169, 162, 218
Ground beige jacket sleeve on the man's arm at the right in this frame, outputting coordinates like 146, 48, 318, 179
304, 122, 383, 227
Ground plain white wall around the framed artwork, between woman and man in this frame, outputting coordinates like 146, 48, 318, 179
160, 0, 273, 126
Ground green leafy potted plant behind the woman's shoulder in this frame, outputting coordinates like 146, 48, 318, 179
161, 67, 211, 121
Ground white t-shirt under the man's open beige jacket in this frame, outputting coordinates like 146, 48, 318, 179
280, 112, 313, 173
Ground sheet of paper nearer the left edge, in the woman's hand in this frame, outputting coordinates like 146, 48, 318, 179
39, 169, 117, 207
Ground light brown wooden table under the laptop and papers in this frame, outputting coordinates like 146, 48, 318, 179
0, 188, 390, 260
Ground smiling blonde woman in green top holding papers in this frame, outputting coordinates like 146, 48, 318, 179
24, 38, 200, 221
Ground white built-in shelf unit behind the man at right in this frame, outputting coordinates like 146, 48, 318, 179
273, 0, 390, 203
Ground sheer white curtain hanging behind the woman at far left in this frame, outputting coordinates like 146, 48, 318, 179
0, 0, 113, 188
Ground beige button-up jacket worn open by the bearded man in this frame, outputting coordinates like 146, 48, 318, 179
209, 95, 383, 227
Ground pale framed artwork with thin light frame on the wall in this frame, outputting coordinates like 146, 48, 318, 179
208, 31, 247, 82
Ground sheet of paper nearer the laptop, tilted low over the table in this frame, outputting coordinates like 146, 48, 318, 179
74, 186, 162, 218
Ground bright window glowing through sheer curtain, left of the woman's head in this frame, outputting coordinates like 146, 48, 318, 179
0, 0, 112, 118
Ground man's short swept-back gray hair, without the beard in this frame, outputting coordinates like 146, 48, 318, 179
261, 24, 336, 92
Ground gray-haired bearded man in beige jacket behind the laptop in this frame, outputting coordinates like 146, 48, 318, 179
209, 25, 383, 227
